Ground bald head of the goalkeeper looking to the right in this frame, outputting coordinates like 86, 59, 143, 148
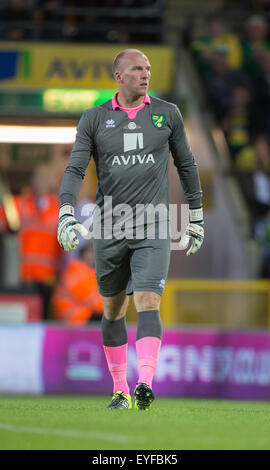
115, 53, 151, 96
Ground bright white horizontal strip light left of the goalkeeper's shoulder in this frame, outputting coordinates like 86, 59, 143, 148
0, 125, 76, 144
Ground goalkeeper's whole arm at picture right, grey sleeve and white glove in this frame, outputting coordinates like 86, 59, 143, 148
169, 106, 204, 256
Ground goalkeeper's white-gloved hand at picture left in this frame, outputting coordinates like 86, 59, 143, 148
57, 204, 88, 251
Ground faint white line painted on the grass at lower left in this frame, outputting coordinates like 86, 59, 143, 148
0, 423, 143, 442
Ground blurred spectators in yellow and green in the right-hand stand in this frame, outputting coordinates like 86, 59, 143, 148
189, 9, 270, 278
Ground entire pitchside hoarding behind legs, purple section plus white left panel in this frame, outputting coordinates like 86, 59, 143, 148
0, 324, 270, 400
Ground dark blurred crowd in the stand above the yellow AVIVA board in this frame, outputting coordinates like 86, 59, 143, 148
0, 0, 164, 43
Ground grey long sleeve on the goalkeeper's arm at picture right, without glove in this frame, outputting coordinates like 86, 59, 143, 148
169, 106, 202, 209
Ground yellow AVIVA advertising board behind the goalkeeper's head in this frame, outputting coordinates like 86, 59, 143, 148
0, 42, 175, 93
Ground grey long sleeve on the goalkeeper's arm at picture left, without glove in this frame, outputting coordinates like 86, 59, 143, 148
59, 113, 94, 206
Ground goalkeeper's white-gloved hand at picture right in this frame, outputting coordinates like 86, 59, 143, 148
179, 207, 204, 256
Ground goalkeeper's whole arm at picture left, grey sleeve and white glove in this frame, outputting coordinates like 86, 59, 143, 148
57, 113, 94, 251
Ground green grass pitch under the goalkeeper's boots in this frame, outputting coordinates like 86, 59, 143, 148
0, 395, 270, 450
